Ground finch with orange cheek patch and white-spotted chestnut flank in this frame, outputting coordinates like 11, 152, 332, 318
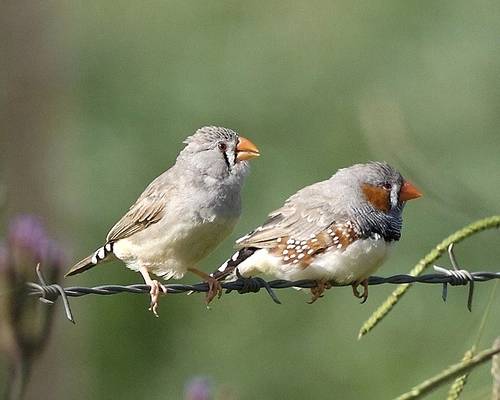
212, 162, 422, 302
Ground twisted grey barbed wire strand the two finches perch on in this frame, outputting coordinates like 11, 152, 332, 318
27, 258, 500, 323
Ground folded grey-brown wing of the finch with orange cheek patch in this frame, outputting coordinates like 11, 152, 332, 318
236, 184, 336, 248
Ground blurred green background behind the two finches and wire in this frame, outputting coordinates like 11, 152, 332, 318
0, 0, 500, 400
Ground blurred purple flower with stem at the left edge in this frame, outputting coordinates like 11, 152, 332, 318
0, 215, 65, 398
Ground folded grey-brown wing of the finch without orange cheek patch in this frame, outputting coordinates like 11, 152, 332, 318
106, 175, 169, 242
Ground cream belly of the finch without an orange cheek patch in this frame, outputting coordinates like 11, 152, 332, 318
113, 219, 236, 279
